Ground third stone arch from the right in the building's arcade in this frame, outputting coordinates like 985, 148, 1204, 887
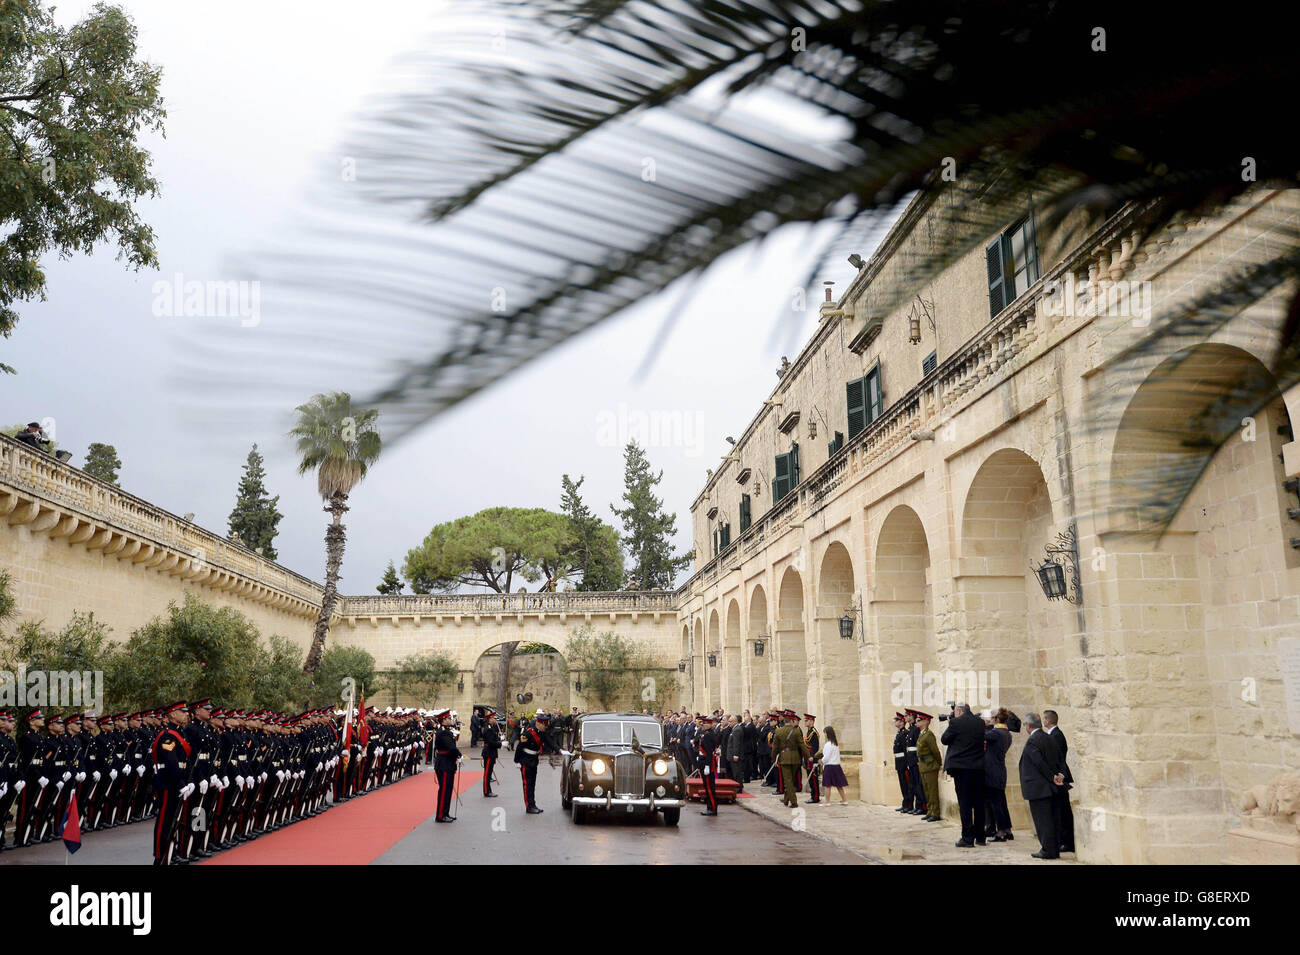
862, 504, 939, 802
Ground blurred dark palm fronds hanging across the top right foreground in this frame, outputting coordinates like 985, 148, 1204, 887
208, 0, 1300, 530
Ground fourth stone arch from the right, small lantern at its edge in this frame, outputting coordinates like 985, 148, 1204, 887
809, 541, 862, 752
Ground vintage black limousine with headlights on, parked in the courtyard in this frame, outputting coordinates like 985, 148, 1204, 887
560, 713, 686, 825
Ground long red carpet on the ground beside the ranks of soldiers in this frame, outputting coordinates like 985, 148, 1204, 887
203, 769, 482, 865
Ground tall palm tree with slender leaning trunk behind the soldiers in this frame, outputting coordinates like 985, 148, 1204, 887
289, 391, 381, 674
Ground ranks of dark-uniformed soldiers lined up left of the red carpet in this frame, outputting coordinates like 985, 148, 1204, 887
0, 699, 432, 865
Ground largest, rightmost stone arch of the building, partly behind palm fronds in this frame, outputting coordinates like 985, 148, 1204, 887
1101, 343, 1300, 848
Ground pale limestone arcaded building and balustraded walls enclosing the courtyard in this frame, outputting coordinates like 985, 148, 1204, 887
0, 191, 1300, 863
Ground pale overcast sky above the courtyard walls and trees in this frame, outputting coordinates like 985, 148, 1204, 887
0, 0, 870, 594
